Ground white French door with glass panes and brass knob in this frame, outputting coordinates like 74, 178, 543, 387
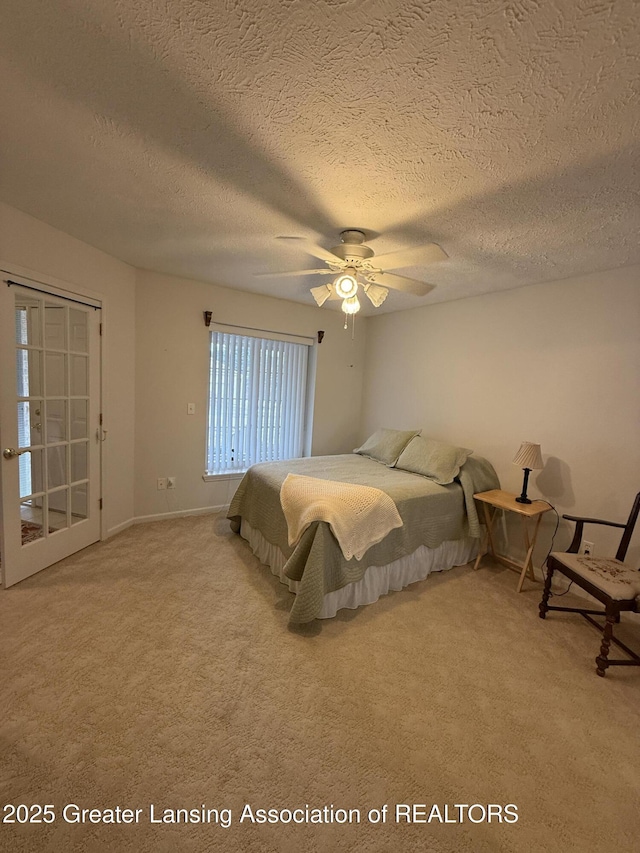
0, 280, 102, 587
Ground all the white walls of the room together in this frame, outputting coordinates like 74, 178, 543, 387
0, 197, 640, 563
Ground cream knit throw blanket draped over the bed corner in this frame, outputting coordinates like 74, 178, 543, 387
280, 474, 402, 560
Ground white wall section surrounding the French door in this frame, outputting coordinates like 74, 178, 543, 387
0, 202, 135, 533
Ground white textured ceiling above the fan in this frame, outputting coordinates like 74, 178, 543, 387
0, 0, 640, 313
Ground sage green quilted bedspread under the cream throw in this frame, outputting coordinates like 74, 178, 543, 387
227, 453, 500, 623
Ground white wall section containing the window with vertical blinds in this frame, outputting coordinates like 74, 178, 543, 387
135, 271, 366, 518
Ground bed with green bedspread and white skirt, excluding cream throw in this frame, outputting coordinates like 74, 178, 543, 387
227, 431, 499, 624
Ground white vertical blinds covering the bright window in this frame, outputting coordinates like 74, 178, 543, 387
207, 332, 308, 474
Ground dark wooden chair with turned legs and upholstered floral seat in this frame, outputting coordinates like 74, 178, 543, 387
540, 492, 640, 676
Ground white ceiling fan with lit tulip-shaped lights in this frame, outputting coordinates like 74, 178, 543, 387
258, 228, 448, 314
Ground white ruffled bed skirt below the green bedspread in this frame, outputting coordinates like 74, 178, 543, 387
240, 519, 479, 619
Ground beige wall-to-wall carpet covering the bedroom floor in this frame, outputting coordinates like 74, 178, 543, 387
0, 516, 640, 853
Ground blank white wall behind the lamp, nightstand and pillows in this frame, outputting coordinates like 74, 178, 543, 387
360, 267, 640, 564
